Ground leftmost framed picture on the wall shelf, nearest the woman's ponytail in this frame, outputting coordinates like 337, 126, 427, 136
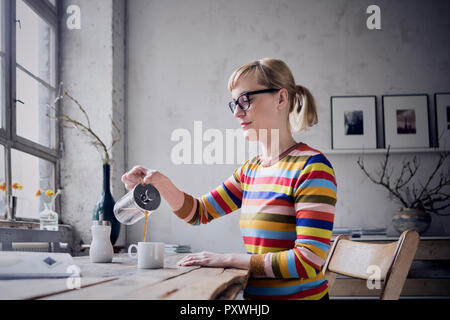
331, 96, 377, 149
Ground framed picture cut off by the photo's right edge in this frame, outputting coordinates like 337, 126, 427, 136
434, 92, 450, 150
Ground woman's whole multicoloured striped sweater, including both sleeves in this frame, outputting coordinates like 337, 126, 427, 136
174, 142, 337, 299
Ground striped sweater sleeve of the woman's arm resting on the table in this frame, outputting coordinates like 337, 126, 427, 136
250, 154, 337, 279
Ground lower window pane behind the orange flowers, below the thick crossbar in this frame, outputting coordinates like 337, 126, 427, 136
11, 149, 55, 219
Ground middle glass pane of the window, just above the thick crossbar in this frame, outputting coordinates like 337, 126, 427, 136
16, 69, 56, 148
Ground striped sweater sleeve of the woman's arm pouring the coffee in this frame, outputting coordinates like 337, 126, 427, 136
173, 163, 245, 225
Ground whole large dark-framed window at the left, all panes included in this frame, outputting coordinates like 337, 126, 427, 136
0, 0, 60, 220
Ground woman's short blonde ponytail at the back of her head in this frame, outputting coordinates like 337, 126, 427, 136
289, 85, 318, 133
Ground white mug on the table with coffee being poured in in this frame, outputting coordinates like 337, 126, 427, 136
128, 242, 165, 269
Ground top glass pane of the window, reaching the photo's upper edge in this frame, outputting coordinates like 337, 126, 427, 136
16, 0, 55, 86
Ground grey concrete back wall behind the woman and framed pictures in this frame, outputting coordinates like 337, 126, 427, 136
127, 0, 450, 252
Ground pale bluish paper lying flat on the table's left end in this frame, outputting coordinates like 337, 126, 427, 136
0, 251, 81, 280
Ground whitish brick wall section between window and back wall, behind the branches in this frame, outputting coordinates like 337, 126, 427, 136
61, 0, 126, 252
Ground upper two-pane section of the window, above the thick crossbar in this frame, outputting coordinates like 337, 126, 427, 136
16, 0, 56, 148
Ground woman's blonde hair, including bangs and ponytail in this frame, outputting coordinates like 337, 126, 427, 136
228, 58, 318, 133
